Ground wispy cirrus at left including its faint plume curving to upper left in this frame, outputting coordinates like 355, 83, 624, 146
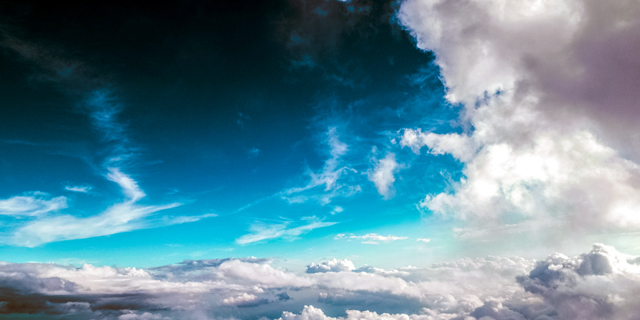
0, 29, 215, 247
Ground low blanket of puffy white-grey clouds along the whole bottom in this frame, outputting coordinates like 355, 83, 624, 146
0, 244, 640, 320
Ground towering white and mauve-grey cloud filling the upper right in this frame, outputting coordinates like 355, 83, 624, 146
399, 0, 640, 234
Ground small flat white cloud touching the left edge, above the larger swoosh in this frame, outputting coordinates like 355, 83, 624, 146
0, 192, 67, 216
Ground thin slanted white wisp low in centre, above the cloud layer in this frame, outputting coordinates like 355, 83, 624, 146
236, 217, 337, 245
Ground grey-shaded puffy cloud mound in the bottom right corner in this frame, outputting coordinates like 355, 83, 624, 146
518, 244, 640, 319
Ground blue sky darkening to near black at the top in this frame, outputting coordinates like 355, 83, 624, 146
0, 2, 470, 267
